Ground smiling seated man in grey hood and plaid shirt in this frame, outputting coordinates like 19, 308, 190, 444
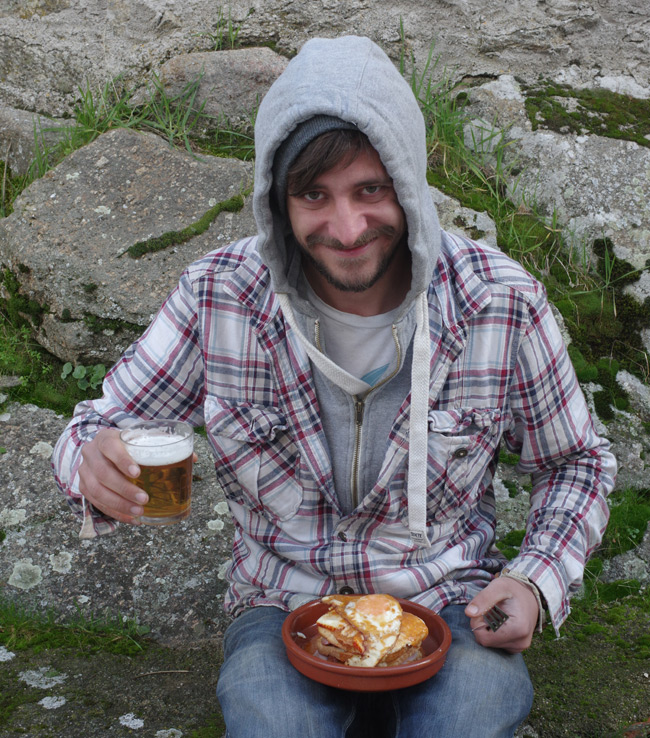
55, 37, 615, 738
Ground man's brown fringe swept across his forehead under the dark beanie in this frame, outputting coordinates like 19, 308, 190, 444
287, 129, 373, 195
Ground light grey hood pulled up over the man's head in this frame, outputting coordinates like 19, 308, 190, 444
253, 36, 440, 303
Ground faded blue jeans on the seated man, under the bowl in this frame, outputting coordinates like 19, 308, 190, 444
217, 605, 533, 738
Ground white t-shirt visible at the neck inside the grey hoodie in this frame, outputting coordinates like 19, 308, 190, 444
305, 280, 399, 388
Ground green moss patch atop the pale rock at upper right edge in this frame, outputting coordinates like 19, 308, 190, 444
523, 81, 650, 146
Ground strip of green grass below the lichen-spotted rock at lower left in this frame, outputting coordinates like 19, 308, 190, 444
0, 598, 148, 655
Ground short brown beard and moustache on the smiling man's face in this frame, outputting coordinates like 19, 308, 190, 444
298, 226, 406, 292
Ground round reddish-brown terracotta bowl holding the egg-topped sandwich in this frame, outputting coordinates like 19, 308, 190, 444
282, 598, 451, 692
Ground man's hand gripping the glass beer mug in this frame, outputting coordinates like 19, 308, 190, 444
79, 428, 148, 525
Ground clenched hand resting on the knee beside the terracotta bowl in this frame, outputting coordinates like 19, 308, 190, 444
465, 577, 539, 653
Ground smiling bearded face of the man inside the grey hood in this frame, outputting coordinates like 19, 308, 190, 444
287, 150, 408, 307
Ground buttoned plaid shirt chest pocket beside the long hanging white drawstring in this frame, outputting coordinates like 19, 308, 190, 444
427, 408, 503, 522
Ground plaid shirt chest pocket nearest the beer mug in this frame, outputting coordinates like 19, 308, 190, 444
204, 396, 303, 523
